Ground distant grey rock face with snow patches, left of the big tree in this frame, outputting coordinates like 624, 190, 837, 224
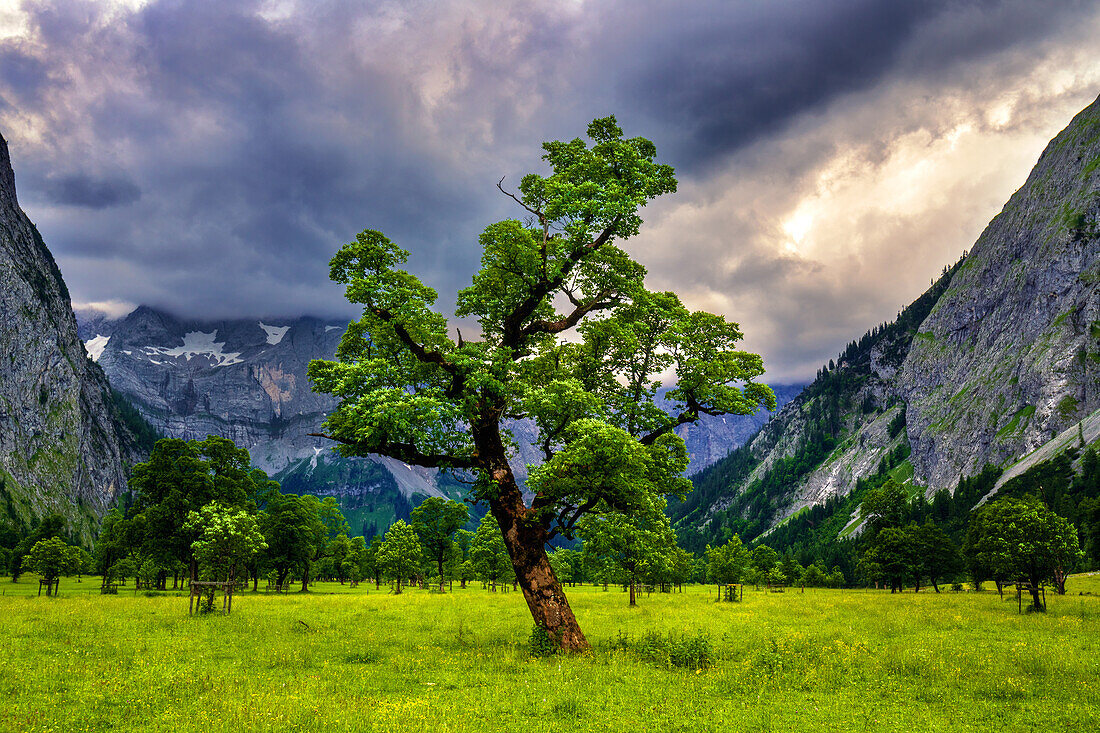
89, 306, 343, 473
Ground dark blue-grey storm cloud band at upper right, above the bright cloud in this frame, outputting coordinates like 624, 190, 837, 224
617, 0, 1084, 169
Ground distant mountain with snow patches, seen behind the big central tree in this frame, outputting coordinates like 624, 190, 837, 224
78, 306, 800, 534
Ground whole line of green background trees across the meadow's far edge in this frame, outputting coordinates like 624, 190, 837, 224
12, 437, 1100, 609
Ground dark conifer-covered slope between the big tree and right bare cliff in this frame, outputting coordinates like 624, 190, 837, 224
670, 262, 961, 547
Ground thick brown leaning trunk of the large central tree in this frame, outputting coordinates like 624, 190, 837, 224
490, 479, 591, 652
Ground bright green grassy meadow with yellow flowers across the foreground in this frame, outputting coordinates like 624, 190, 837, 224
0, 576, 1100, 732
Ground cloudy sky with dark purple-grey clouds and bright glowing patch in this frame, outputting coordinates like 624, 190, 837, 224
0, 0, 1100, 382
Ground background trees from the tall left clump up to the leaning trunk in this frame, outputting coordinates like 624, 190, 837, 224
91, 436, 528, 592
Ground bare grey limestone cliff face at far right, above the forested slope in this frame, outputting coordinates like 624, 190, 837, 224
895, 93, 1100, 490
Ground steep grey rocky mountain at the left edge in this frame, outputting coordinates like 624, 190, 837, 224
0, 132, 142, 541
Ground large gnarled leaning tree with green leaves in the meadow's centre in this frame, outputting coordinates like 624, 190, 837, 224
309, 118, 776, 649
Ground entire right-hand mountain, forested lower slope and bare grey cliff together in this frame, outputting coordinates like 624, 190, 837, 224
672, 91, 1100, 544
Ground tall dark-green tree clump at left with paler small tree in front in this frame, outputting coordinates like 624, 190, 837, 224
95, 436, 356, 590
